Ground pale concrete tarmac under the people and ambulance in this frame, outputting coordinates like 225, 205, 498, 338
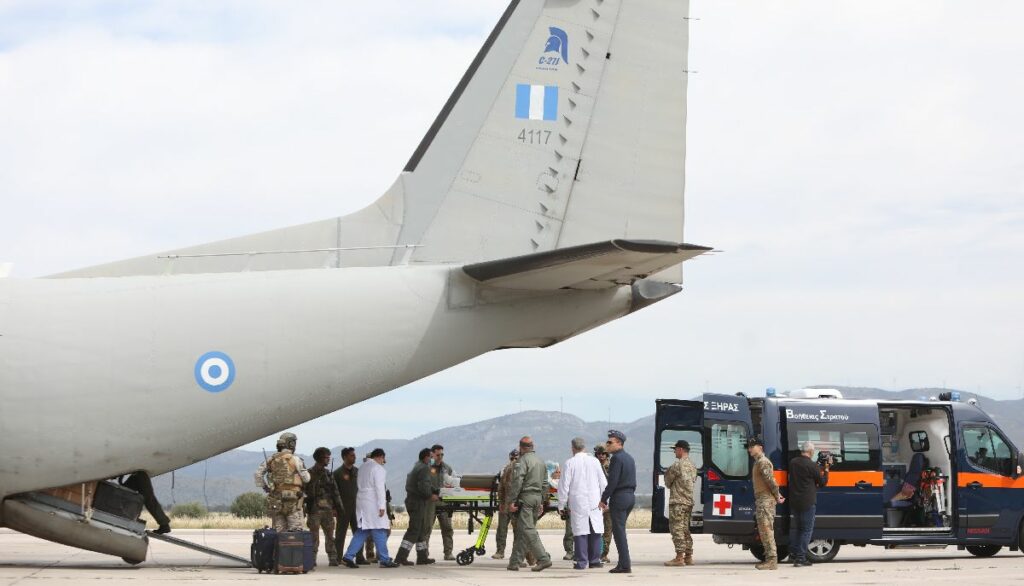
0, 530, 1024, 586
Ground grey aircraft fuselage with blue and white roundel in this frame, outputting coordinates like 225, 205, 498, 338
0, 265, 633, 498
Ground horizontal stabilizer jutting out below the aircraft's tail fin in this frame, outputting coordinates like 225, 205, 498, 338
463, 240, 711, 291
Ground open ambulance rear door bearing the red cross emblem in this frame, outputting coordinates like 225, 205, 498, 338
701, 394, 755, 535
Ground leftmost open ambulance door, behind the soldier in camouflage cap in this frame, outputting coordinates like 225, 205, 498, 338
650, 400, 703, 533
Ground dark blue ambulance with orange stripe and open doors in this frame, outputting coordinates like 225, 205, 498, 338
651, 389, 1024, 562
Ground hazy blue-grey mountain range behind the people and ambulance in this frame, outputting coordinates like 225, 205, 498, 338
154, 386, 1024, 508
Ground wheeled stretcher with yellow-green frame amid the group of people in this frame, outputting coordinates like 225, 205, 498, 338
437, 474, 558, 566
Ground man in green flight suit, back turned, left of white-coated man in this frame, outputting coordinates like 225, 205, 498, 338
503, 435, 551, 572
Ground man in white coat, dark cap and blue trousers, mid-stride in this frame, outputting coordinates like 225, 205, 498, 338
341, 448, 398, 569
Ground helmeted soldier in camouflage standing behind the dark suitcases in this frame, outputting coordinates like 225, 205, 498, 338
255, 433, 309, 532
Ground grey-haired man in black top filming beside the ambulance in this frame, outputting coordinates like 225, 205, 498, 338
788, 442, 833, 568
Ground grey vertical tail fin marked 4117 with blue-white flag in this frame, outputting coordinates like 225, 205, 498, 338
58, 0, 689, 283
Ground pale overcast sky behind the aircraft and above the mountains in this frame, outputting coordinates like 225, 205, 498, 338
0, 0, 1024, 446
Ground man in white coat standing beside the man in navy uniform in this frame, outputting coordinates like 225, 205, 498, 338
558, 437, 608, 570
